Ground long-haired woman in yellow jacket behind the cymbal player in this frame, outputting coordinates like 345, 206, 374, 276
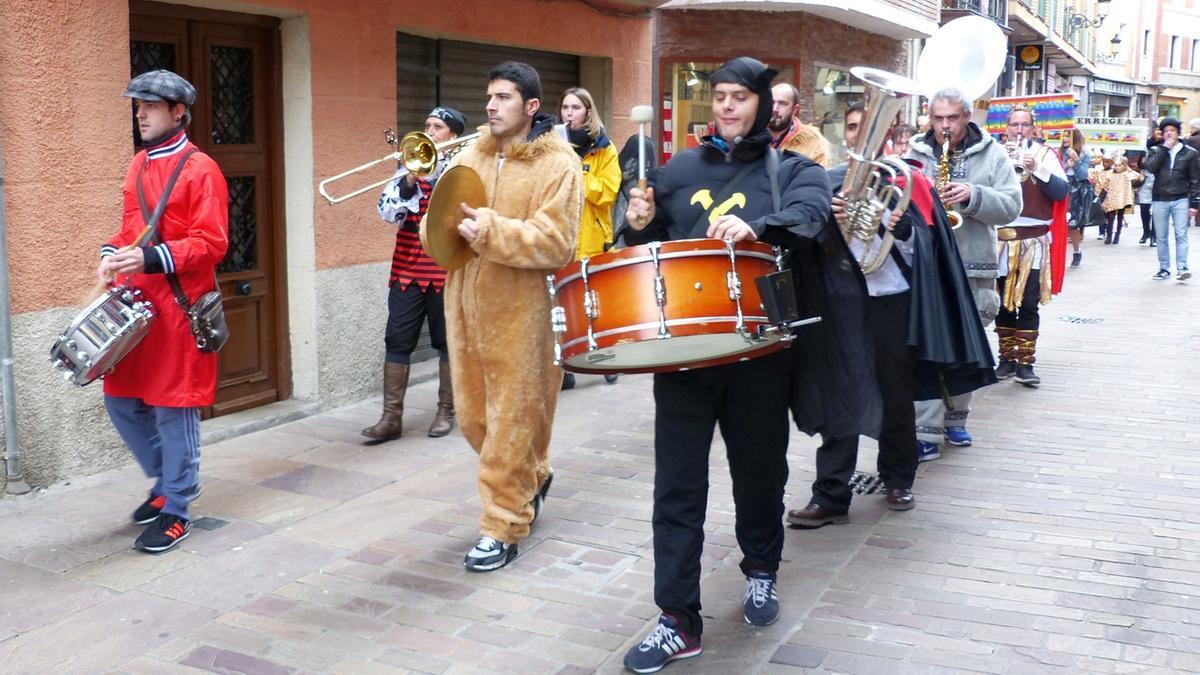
559, 86, 620, 389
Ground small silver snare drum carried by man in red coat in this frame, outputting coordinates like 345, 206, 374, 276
50, 286, 155, 387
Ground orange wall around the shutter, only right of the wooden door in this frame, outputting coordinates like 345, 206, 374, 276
296, 0, 653, 269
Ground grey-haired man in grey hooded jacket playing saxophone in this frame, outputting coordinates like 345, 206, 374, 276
905, 88, 1022, 461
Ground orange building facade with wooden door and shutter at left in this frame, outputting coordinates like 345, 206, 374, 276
0, 0, 658, 483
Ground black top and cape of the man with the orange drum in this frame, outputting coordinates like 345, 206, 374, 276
625, 133, 882, 437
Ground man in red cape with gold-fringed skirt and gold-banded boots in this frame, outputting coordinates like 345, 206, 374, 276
996, 104, 1070, 387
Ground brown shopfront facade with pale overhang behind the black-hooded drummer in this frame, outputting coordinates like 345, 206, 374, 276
654, 0, 940, 160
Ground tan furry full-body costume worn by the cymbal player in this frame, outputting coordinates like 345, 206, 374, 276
421, 127, 583, 544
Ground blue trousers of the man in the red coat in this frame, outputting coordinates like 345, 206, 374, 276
104, 396, 200, 520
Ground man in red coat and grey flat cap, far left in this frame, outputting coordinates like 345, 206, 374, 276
96, 70, 229, 552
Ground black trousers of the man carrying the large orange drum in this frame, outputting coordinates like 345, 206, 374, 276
653, 350, 792, 634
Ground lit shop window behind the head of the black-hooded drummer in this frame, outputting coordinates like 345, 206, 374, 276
659, 61, 796, 161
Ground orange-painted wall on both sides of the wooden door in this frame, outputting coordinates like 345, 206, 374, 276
0, 0, 653, 313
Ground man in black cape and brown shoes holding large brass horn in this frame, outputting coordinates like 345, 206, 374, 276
787, 107, 995, 530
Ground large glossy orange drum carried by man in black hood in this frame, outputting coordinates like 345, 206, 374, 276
547, 239, 788, 374
